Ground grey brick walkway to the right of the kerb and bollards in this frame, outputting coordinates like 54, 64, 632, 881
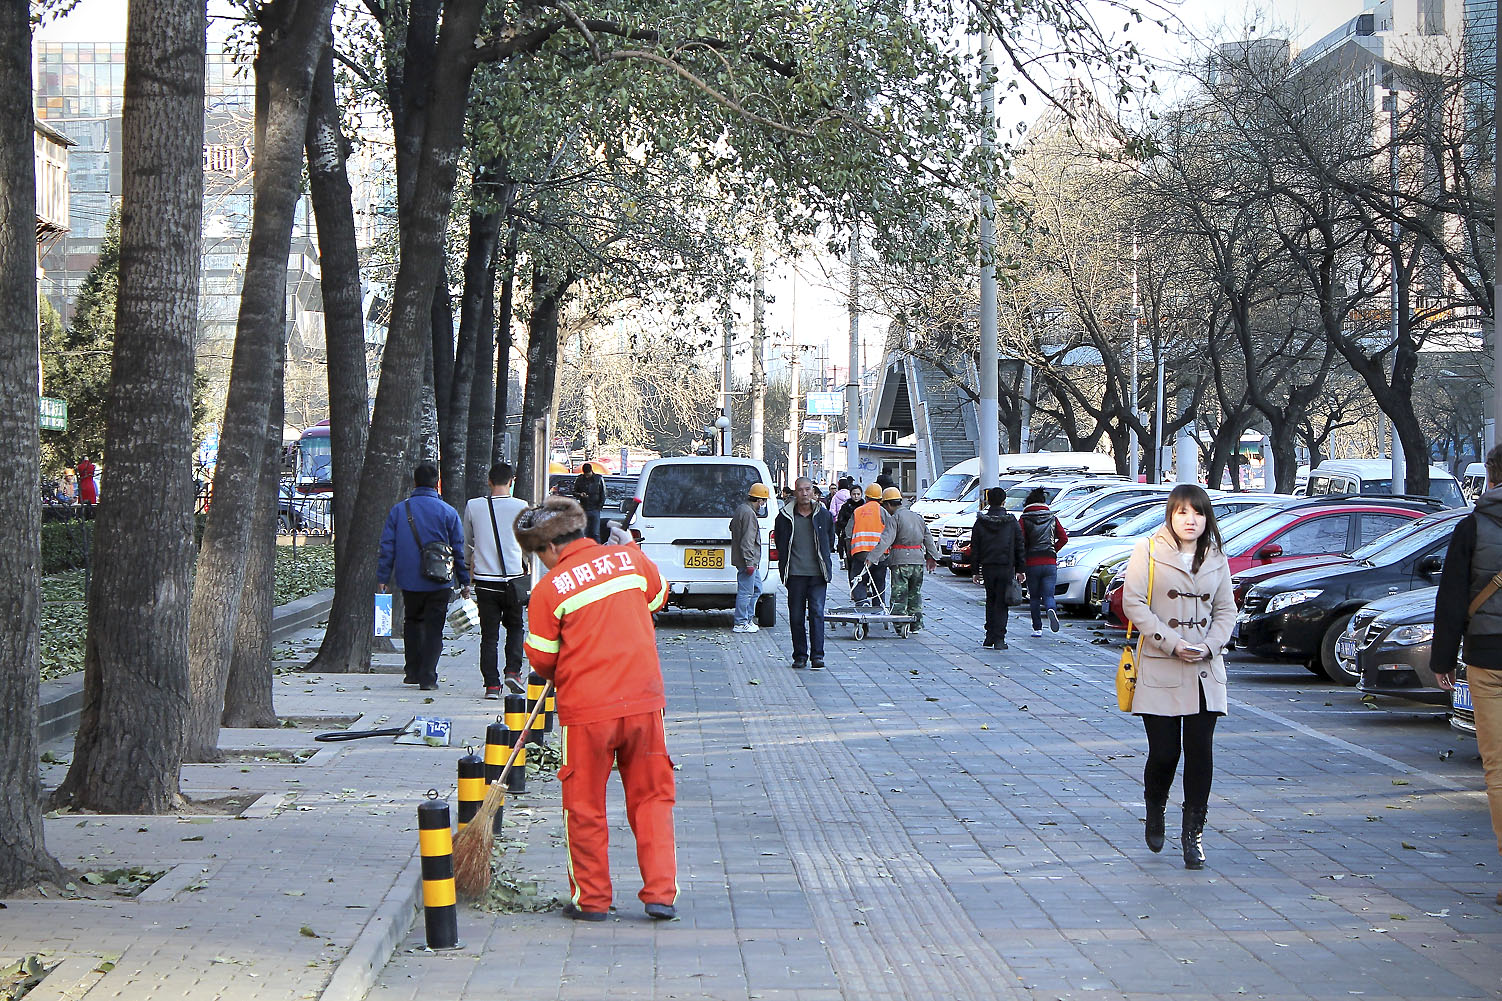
369, 576, 1502, 1001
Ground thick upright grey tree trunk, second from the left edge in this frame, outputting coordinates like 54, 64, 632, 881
52, 0, 207, 813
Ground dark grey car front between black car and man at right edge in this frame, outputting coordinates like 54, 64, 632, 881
1335, 588, 1449, 705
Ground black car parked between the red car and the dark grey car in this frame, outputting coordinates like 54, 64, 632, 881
1236, 510, 1469, 685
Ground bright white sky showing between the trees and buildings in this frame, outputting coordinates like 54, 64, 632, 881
38, 0, 1376, 393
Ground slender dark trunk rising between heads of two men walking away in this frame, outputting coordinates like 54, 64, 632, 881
439, 201, 500, 510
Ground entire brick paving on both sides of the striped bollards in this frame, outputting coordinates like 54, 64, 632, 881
0, 576, 1502, 1001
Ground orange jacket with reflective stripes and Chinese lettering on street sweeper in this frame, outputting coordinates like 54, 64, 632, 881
526, 538, 667, 726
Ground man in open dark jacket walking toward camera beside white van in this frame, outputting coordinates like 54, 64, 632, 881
772, 476, 835, 670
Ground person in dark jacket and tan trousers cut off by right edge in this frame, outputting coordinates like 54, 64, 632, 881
1430, 445, 1502, 903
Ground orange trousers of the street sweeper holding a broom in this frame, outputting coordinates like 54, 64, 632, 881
559, 712, 677, 911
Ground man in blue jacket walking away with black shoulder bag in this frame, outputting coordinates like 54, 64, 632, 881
376, 463, 470, 691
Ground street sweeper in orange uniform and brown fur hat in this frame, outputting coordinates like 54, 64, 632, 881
515, 496, 677, 921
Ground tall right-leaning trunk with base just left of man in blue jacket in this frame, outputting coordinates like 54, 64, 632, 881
311, 0, 484, 672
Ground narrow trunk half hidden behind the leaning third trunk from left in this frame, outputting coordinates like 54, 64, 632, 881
219, 314, 283, 727
